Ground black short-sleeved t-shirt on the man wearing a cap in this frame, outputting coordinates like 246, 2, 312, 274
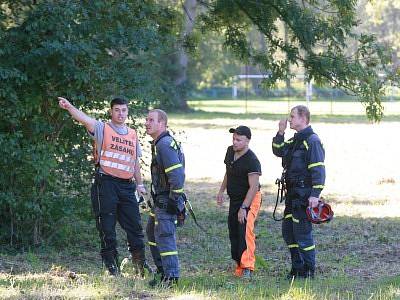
224, 146, 261, 204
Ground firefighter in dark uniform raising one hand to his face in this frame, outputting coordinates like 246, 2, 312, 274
272, 105, 325, 278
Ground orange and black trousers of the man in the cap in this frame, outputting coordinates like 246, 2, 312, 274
228, 192, 261, 276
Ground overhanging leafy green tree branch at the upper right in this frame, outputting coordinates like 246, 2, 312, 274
201, 0, 397, 121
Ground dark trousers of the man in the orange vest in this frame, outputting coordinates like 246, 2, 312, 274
91, 175, 144, 260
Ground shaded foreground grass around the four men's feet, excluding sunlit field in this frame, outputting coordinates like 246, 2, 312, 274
0, 182, 400, 299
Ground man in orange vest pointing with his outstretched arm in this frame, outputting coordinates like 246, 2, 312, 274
58, 97, 146, 276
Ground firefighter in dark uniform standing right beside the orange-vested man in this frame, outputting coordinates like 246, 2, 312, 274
146, 109, 185, 286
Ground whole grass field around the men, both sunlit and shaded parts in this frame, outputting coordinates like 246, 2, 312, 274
0, 106, 400, 299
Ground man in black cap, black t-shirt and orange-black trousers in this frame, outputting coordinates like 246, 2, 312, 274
217, 126, 261, 278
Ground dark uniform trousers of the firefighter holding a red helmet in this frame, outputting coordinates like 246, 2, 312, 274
282, 187, 315, 272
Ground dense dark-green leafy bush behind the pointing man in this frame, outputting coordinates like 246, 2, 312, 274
0, 0, 176, 245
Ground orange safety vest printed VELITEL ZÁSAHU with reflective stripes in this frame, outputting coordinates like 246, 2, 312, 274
99, 123, 137, 179
